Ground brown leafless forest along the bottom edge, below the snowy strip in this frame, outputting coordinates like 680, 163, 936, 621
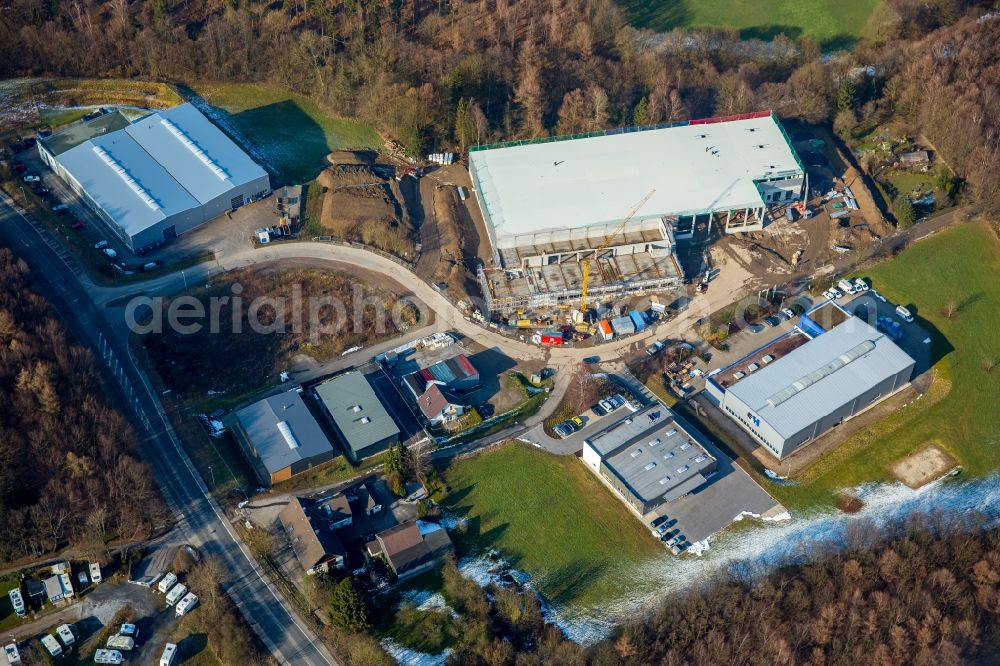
376, 515, 1000, 666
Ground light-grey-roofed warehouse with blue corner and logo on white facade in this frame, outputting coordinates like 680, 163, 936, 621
706, 301, 915, 460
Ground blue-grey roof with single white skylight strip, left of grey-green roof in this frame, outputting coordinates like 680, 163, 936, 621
236, 389, 333, 473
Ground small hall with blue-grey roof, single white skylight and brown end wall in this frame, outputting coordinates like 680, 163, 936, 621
233, 389, 336, 485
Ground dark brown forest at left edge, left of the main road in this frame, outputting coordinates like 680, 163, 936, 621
0, 248, 167, 562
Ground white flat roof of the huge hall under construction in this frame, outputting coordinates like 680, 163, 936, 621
469, 112, 803, 243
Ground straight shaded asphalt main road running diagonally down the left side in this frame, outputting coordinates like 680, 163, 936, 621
0, 193, 338, 666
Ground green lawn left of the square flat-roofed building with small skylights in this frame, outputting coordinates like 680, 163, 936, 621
442, 443, 663, 608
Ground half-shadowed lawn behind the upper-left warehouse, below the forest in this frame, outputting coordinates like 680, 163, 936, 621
191, 83, 382, 183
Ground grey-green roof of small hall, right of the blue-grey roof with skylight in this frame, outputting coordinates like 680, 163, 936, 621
315, 372, 399, 452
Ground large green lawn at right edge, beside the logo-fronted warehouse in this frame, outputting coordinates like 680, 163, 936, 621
768, 223, 1000, 507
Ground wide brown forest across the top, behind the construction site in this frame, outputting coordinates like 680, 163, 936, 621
0, 0, 1000, 210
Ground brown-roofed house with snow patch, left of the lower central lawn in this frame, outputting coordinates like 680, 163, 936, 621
367, 520, 455, 580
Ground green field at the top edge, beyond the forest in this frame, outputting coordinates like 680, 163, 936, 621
619, 0, 879, 48
